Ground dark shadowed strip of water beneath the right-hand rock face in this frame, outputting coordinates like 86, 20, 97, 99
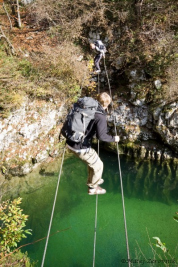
103, 152, 178, 204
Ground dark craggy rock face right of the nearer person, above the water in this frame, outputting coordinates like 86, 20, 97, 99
105, 97, 178, 162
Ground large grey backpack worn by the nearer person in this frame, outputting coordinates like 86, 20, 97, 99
61, 96, 98, 143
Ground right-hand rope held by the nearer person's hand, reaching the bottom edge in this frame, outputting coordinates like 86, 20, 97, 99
104, 58, 131, 267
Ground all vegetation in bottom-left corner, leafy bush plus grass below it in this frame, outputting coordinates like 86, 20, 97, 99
0, 198, 31, 266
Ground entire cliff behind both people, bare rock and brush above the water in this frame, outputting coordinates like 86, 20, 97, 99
0, 0, 178, 179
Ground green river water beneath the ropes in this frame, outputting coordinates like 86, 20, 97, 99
18, 152, 178, 267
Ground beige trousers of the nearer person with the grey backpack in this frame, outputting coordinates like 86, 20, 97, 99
70, 148, 103, 188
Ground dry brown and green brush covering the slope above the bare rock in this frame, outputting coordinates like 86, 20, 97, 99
0, 0, 178, 116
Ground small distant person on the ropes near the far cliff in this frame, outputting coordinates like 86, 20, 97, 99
90, 40, 106, 73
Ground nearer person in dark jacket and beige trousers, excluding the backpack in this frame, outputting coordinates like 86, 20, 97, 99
66, 92, 120, 195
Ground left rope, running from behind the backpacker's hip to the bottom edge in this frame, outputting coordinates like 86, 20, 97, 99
41, 147, 66, 267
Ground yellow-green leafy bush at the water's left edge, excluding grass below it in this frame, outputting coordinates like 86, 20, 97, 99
0, 198, 31, 254
